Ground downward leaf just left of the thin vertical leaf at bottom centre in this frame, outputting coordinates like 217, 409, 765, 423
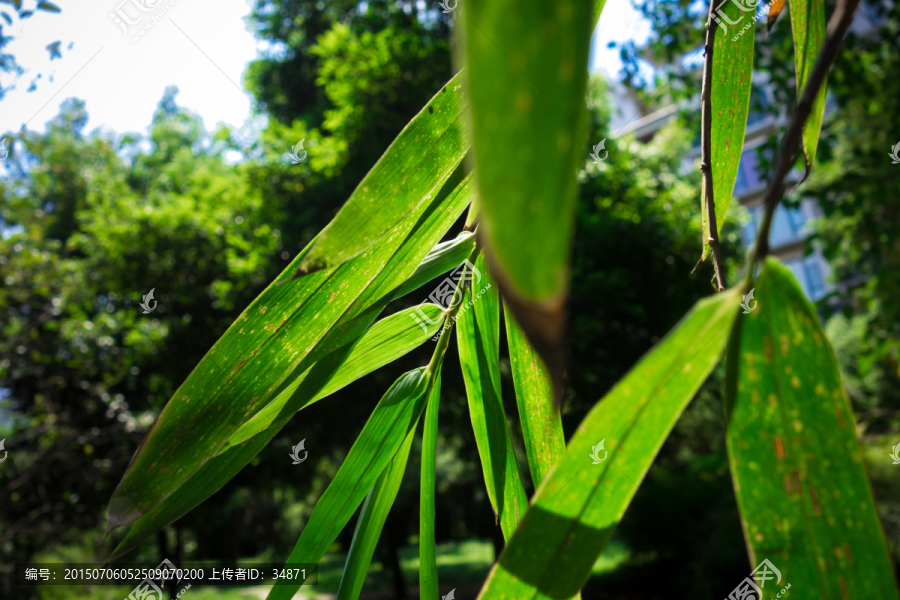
337, 374, 428, 600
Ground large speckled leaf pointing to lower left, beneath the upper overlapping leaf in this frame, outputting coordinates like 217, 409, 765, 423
108, 198, 444, 528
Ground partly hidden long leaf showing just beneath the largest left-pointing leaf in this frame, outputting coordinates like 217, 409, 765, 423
114, 177, 471, 556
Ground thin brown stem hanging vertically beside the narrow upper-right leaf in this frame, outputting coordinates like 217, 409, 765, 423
695, 0, 725, 292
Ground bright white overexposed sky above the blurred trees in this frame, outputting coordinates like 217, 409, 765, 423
0, 0, 649, 135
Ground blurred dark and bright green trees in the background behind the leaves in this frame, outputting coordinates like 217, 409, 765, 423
0, 0, 900, 600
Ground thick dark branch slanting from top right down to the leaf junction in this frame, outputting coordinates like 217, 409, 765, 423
747, 0, 859, 283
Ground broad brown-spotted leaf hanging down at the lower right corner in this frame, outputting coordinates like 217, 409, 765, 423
725, 258, 900, 600
